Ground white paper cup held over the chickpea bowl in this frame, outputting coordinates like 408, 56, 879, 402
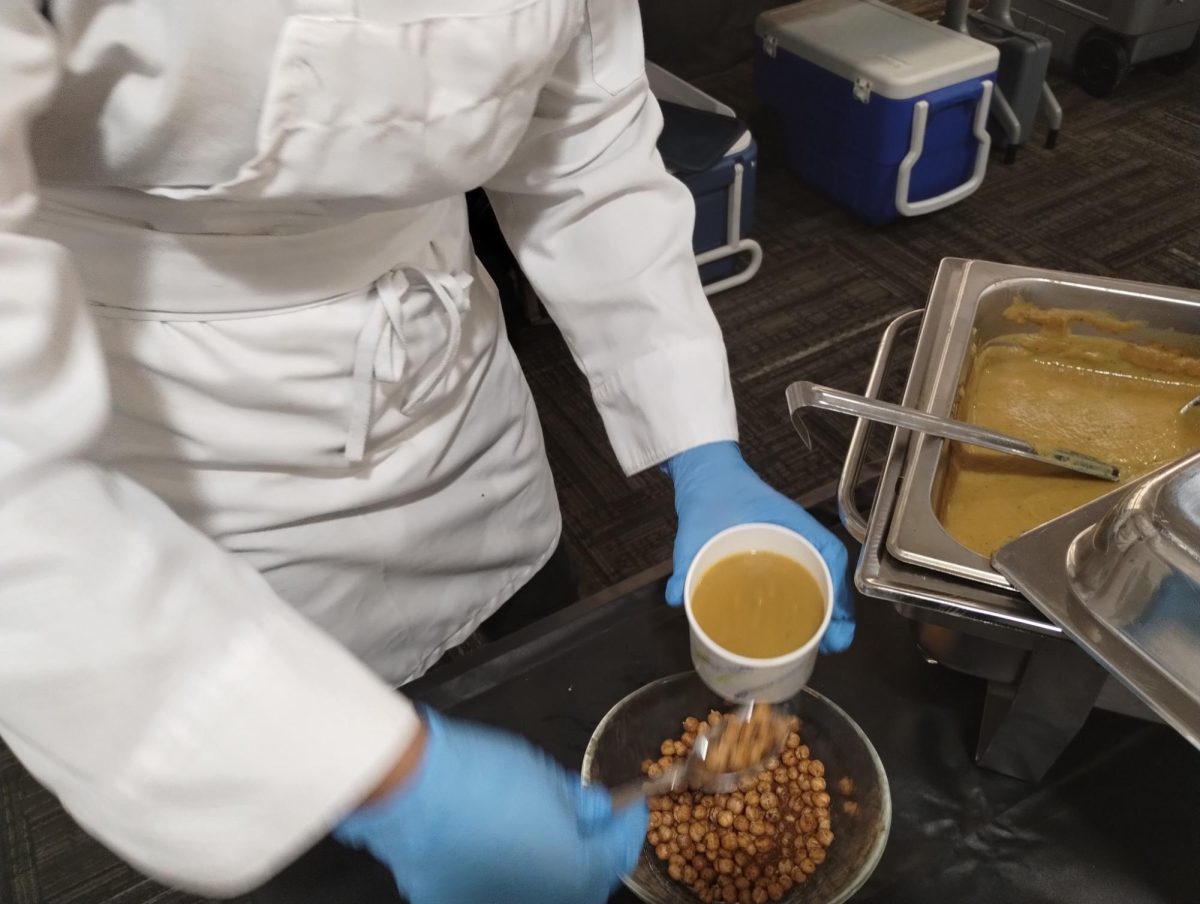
683, 523, 833, 704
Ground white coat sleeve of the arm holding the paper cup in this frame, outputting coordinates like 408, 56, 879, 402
485, 0, 737, 474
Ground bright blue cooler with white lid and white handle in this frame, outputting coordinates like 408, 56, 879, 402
755, 0, 1000, 224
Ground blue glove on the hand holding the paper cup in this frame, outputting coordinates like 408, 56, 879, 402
664, 442, 854, 653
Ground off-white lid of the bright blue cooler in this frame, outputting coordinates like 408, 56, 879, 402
755, 0, 1000, 100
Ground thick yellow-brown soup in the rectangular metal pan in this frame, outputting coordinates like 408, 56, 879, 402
938, 300, 1200, 557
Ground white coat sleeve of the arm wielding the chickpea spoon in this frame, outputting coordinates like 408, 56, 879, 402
0, 0, 418, 896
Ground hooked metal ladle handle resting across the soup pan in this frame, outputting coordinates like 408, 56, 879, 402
787, 381, 1121, 481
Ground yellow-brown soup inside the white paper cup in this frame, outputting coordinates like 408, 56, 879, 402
691, 552, 824, 659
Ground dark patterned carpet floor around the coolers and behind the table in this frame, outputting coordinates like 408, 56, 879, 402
0, 8, 1200, 904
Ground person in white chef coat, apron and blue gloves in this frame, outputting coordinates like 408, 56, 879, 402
0, 0, 853, 904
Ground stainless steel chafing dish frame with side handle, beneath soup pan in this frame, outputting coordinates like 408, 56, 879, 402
838, 258, 1156, 780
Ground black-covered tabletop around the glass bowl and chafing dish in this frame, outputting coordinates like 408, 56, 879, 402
408, 521, 1200, 904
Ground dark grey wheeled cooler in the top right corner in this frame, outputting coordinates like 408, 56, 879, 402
1012, 0, 1200, 97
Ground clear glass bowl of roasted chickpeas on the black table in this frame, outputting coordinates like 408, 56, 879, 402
583, 672, 892, 904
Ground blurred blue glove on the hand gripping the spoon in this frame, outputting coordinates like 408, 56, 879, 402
334, 711, 648, 904
